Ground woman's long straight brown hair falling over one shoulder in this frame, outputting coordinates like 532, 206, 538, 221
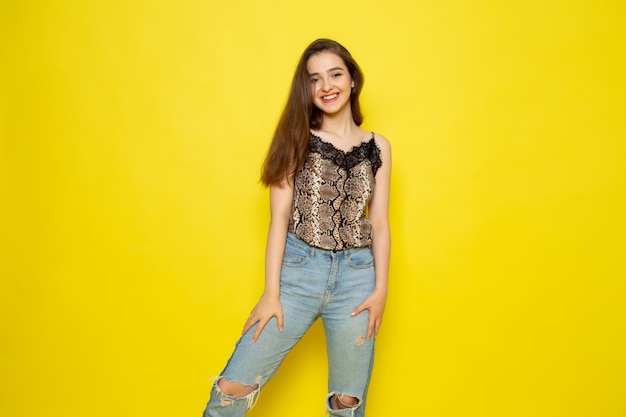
261, 39, 363, 186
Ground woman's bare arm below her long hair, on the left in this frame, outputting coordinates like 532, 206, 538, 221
243, 184, 293, 342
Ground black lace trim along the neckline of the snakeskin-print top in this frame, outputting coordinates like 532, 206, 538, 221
309, 132, 383, 176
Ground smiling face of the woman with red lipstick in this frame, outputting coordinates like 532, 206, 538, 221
306, 51, 354, 114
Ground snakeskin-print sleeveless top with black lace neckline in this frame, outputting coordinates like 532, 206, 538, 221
289, 132, 382, 251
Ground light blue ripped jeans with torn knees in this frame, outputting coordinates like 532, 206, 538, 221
203, 233, 375, 417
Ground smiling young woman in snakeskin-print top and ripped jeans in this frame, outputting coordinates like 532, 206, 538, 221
204, 39, 391, 417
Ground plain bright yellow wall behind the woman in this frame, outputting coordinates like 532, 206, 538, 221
0, 0, 626, 417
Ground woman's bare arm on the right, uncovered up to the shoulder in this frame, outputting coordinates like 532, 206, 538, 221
352, 135, 391, 340
